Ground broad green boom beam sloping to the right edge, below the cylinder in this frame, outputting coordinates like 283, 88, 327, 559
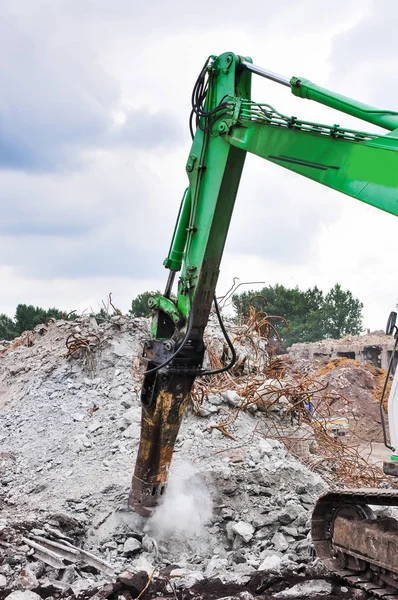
226, 119, 398, 216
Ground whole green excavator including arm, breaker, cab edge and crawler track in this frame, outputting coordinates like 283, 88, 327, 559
128, 52, 398, 600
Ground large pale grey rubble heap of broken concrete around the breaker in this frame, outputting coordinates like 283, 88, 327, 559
0, 315, 388, 600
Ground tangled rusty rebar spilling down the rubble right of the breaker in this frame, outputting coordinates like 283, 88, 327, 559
191, 304, 394, 487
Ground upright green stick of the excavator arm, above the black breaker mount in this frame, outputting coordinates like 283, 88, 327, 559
165, 53, 251, 328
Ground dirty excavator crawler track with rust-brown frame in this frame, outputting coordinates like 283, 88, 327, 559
311, 488, 398, 600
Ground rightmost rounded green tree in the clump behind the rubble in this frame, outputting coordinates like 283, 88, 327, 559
322, 283, 363, 339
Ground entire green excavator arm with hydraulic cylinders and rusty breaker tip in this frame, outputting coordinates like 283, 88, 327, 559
129, 52, 398, 516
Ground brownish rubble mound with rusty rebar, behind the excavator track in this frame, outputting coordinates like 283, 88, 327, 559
202, 312, 391, 487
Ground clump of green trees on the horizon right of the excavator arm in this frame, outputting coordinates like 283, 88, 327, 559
232, 284, 363, 347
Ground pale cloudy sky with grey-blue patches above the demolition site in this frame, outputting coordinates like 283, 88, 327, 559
0, 0, 398, 329
